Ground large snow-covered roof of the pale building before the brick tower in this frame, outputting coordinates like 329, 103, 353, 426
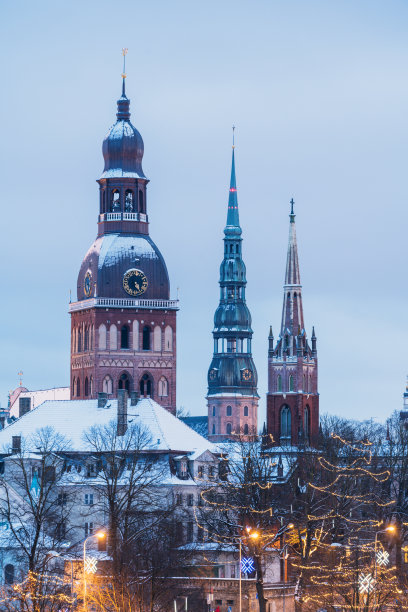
0, 398, 217, 457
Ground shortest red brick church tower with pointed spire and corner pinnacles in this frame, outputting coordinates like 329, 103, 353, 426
267, 200, 319, 446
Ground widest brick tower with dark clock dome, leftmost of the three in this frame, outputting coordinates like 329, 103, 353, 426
69, 69, 178, 413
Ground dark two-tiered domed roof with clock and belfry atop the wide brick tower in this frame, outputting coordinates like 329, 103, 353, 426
77, 67, 170, 302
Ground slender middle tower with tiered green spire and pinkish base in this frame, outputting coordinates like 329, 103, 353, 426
207, 146, 259, 441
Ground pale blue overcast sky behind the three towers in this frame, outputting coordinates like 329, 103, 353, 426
0, 0, 408, 425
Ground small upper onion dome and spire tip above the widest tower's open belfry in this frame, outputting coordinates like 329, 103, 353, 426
101, 79, 146, 179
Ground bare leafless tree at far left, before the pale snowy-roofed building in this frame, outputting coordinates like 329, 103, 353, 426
0, 427, 71, 612
